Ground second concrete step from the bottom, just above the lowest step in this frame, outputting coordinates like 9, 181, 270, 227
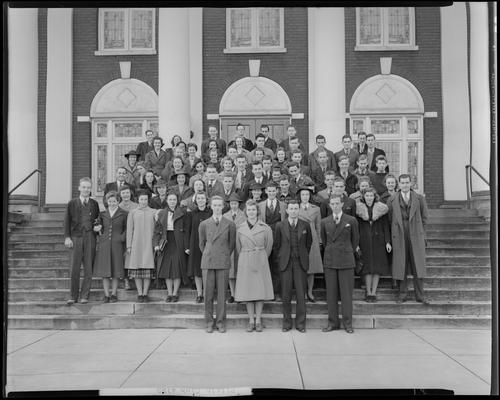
8, 300, 491, 316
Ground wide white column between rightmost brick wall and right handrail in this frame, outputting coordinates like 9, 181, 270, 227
441, 3, 470, 200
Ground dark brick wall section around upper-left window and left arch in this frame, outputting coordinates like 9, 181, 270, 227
72, 8, 158, 196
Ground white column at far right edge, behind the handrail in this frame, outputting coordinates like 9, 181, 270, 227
469, 2, 491, 191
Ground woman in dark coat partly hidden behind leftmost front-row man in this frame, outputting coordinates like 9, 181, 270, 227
187, 192, 212, 303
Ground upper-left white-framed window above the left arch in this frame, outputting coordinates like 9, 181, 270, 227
95, 8, 156, 55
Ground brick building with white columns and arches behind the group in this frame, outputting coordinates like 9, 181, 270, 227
8, 2, 490, 207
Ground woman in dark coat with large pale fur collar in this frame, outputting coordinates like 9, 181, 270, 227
356, 188, 392, 303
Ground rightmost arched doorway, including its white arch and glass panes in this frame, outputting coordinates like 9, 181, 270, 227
349, 74, 424, 193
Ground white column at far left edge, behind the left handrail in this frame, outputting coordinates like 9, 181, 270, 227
7, 8, 38, 196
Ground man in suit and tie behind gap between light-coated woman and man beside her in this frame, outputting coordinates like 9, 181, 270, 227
258, 181, 286, 301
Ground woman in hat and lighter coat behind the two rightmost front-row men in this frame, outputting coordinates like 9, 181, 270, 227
297, 185, 323, 303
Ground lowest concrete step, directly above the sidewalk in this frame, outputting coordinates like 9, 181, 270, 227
8, 314, 491, 335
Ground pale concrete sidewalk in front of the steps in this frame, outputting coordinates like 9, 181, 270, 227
7, 329, 491, 395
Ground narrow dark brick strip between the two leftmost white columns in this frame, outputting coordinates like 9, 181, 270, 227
37, 8, 47, 204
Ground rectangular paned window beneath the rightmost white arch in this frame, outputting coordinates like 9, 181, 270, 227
350, 114, 424, 193
